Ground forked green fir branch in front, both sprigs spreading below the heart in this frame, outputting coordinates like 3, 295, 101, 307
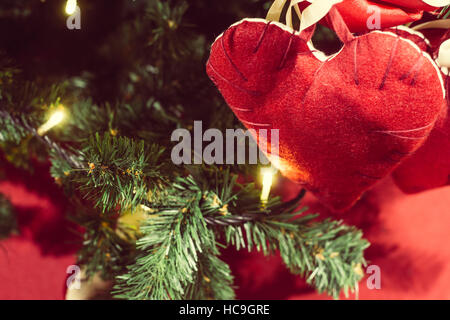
116, 168, 368, 299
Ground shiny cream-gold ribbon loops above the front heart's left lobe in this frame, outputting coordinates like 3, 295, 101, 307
266, 0, 342, 32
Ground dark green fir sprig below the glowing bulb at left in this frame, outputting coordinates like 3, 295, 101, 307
72, 133, 171, 212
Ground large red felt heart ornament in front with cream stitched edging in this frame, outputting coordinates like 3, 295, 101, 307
207, 8, 445, 210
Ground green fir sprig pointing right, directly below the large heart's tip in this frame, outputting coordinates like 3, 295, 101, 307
226, 214, 368, 298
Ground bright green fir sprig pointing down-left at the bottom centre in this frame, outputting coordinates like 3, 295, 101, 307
114, 185, 216, 300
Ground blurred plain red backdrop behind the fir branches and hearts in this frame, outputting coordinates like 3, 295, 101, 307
0, 160, 450, 299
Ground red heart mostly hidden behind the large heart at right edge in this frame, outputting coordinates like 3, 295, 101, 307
393, 29, 450, 193
